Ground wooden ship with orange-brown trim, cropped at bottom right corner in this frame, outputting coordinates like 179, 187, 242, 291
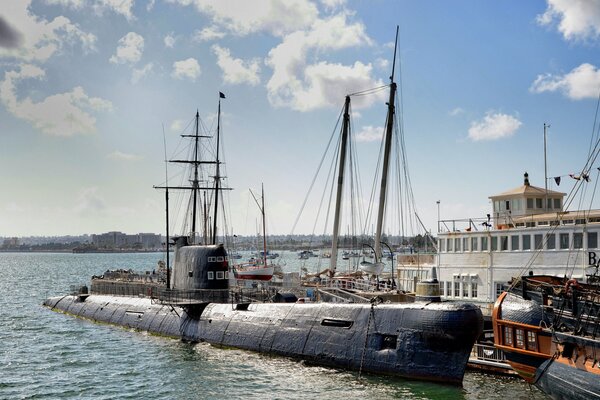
493, 275, 600, 399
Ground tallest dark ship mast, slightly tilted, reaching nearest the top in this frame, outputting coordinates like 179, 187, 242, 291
375, 26, 398, 257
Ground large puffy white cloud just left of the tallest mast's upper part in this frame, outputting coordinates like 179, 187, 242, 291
266, 14, 384, 111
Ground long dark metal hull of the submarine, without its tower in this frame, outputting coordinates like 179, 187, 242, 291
44, 294, 482, 384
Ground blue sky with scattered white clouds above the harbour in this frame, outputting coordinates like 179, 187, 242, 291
0, 0, 600, 236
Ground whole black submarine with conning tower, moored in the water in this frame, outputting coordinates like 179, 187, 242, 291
44, 237, 482, 384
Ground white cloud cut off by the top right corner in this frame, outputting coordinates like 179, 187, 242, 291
537, 0, 600, 40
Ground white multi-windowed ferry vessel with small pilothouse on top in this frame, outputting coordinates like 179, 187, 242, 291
436, 173, 600, 315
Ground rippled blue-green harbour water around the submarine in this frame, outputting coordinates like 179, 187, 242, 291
0, 253, 545, 400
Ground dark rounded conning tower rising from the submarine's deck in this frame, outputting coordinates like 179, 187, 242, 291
167, 236, 229, 303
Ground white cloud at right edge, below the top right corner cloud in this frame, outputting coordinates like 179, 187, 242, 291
529, 63, 600, 100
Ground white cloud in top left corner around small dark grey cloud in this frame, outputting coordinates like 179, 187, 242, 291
0, 0, 96, 62
